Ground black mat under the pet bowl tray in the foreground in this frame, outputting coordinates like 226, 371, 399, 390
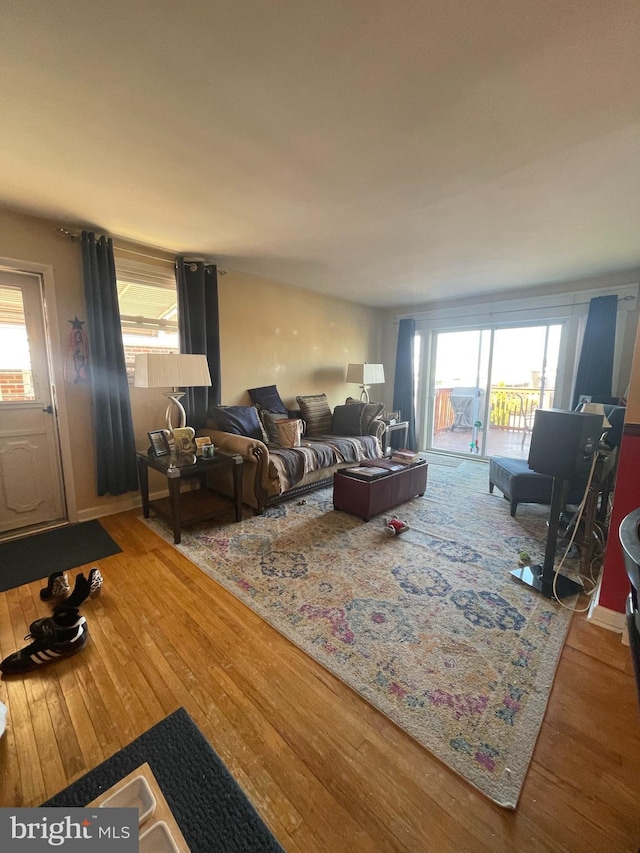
42, 708, 283, 853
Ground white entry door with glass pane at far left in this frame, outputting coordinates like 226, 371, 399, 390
0, 270, 66, 533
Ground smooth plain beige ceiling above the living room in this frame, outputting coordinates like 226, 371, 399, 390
0, 0, 640, 306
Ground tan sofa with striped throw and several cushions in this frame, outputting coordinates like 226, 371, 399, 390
200, 386, 386, 514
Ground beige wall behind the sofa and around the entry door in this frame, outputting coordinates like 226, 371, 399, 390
0, 208, 382, 520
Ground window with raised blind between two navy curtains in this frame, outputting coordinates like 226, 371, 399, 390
114, 249, 178, 382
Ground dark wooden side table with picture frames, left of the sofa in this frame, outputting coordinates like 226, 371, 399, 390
136, 452, 243, 545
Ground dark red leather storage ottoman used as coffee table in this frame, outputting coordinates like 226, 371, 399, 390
333, 460, 429, 521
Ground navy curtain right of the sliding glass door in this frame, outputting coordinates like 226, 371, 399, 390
572, 296, 618, 409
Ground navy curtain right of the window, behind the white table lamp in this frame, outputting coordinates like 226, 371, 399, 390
176, 256, 220, 430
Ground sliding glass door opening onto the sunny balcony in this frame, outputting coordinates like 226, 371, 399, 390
423, 324, 562, 459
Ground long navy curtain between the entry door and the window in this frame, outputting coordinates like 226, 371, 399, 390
81, 231, 138, 496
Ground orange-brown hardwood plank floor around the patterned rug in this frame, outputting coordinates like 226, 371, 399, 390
0, 511, 640, 853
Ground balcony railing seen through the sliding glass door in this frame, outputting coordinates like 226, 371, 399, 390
433, 385, 554, 434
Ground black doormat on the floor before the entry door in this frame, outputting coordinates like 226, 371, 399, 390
0, 521, 122, 592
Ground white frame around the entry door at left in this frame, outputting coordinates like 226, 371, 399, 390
0, 257, 78, 522
